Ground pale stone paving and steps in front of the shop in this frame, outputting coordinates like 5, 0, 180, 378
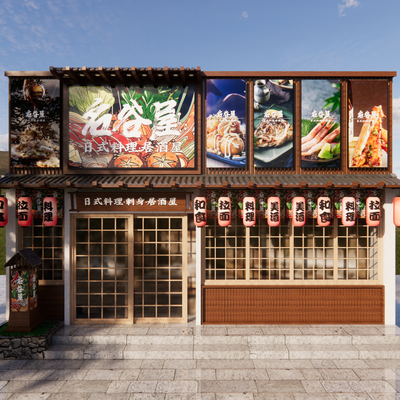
0, 322, 400, 400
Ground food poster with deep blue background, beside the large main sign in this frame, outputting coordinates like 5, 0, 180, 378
206, 79, 246, 168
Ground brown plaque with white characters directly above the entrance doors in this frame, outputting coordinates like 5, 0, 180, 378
76, 193, 186, 212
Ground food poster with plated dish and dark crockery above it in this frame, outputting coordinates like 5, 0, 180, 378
254, 79, 293, 167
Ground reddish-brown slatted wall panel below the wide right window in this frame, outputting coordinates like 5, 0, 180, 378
202, 286, 385, 325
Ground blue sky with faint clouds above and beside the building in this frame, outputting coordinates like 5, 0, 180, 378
0, 0, 400, 176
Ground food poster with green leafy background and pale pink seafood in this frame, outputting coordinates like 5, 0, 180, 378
301, 79, 341, 168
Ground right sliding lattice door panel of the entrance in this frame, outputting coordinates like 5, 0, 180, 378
134, 217, 187, 320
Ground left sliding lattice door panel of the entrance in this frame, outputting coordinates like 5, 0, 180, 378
75, 217, 129, 319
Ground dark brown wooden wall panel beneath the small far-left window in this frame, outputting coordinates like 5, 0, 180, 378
38, 284, 64, 321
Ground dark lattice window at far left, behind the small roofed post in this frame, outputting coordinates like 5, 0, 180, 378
19, 218, 64, 282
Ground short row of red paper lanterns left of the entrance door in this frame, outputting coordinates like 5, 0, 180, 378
0, 197, 57, 227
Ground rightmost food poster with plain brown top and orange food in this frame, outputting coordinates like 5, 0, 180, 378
349, 80, 388, 168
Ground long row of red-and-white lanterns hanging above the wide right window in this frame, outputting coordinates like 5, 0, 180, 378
193, 197, 382, 227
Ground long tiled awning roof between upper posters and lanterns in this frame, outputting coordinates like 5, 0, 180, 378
0, 174, 400, 189
